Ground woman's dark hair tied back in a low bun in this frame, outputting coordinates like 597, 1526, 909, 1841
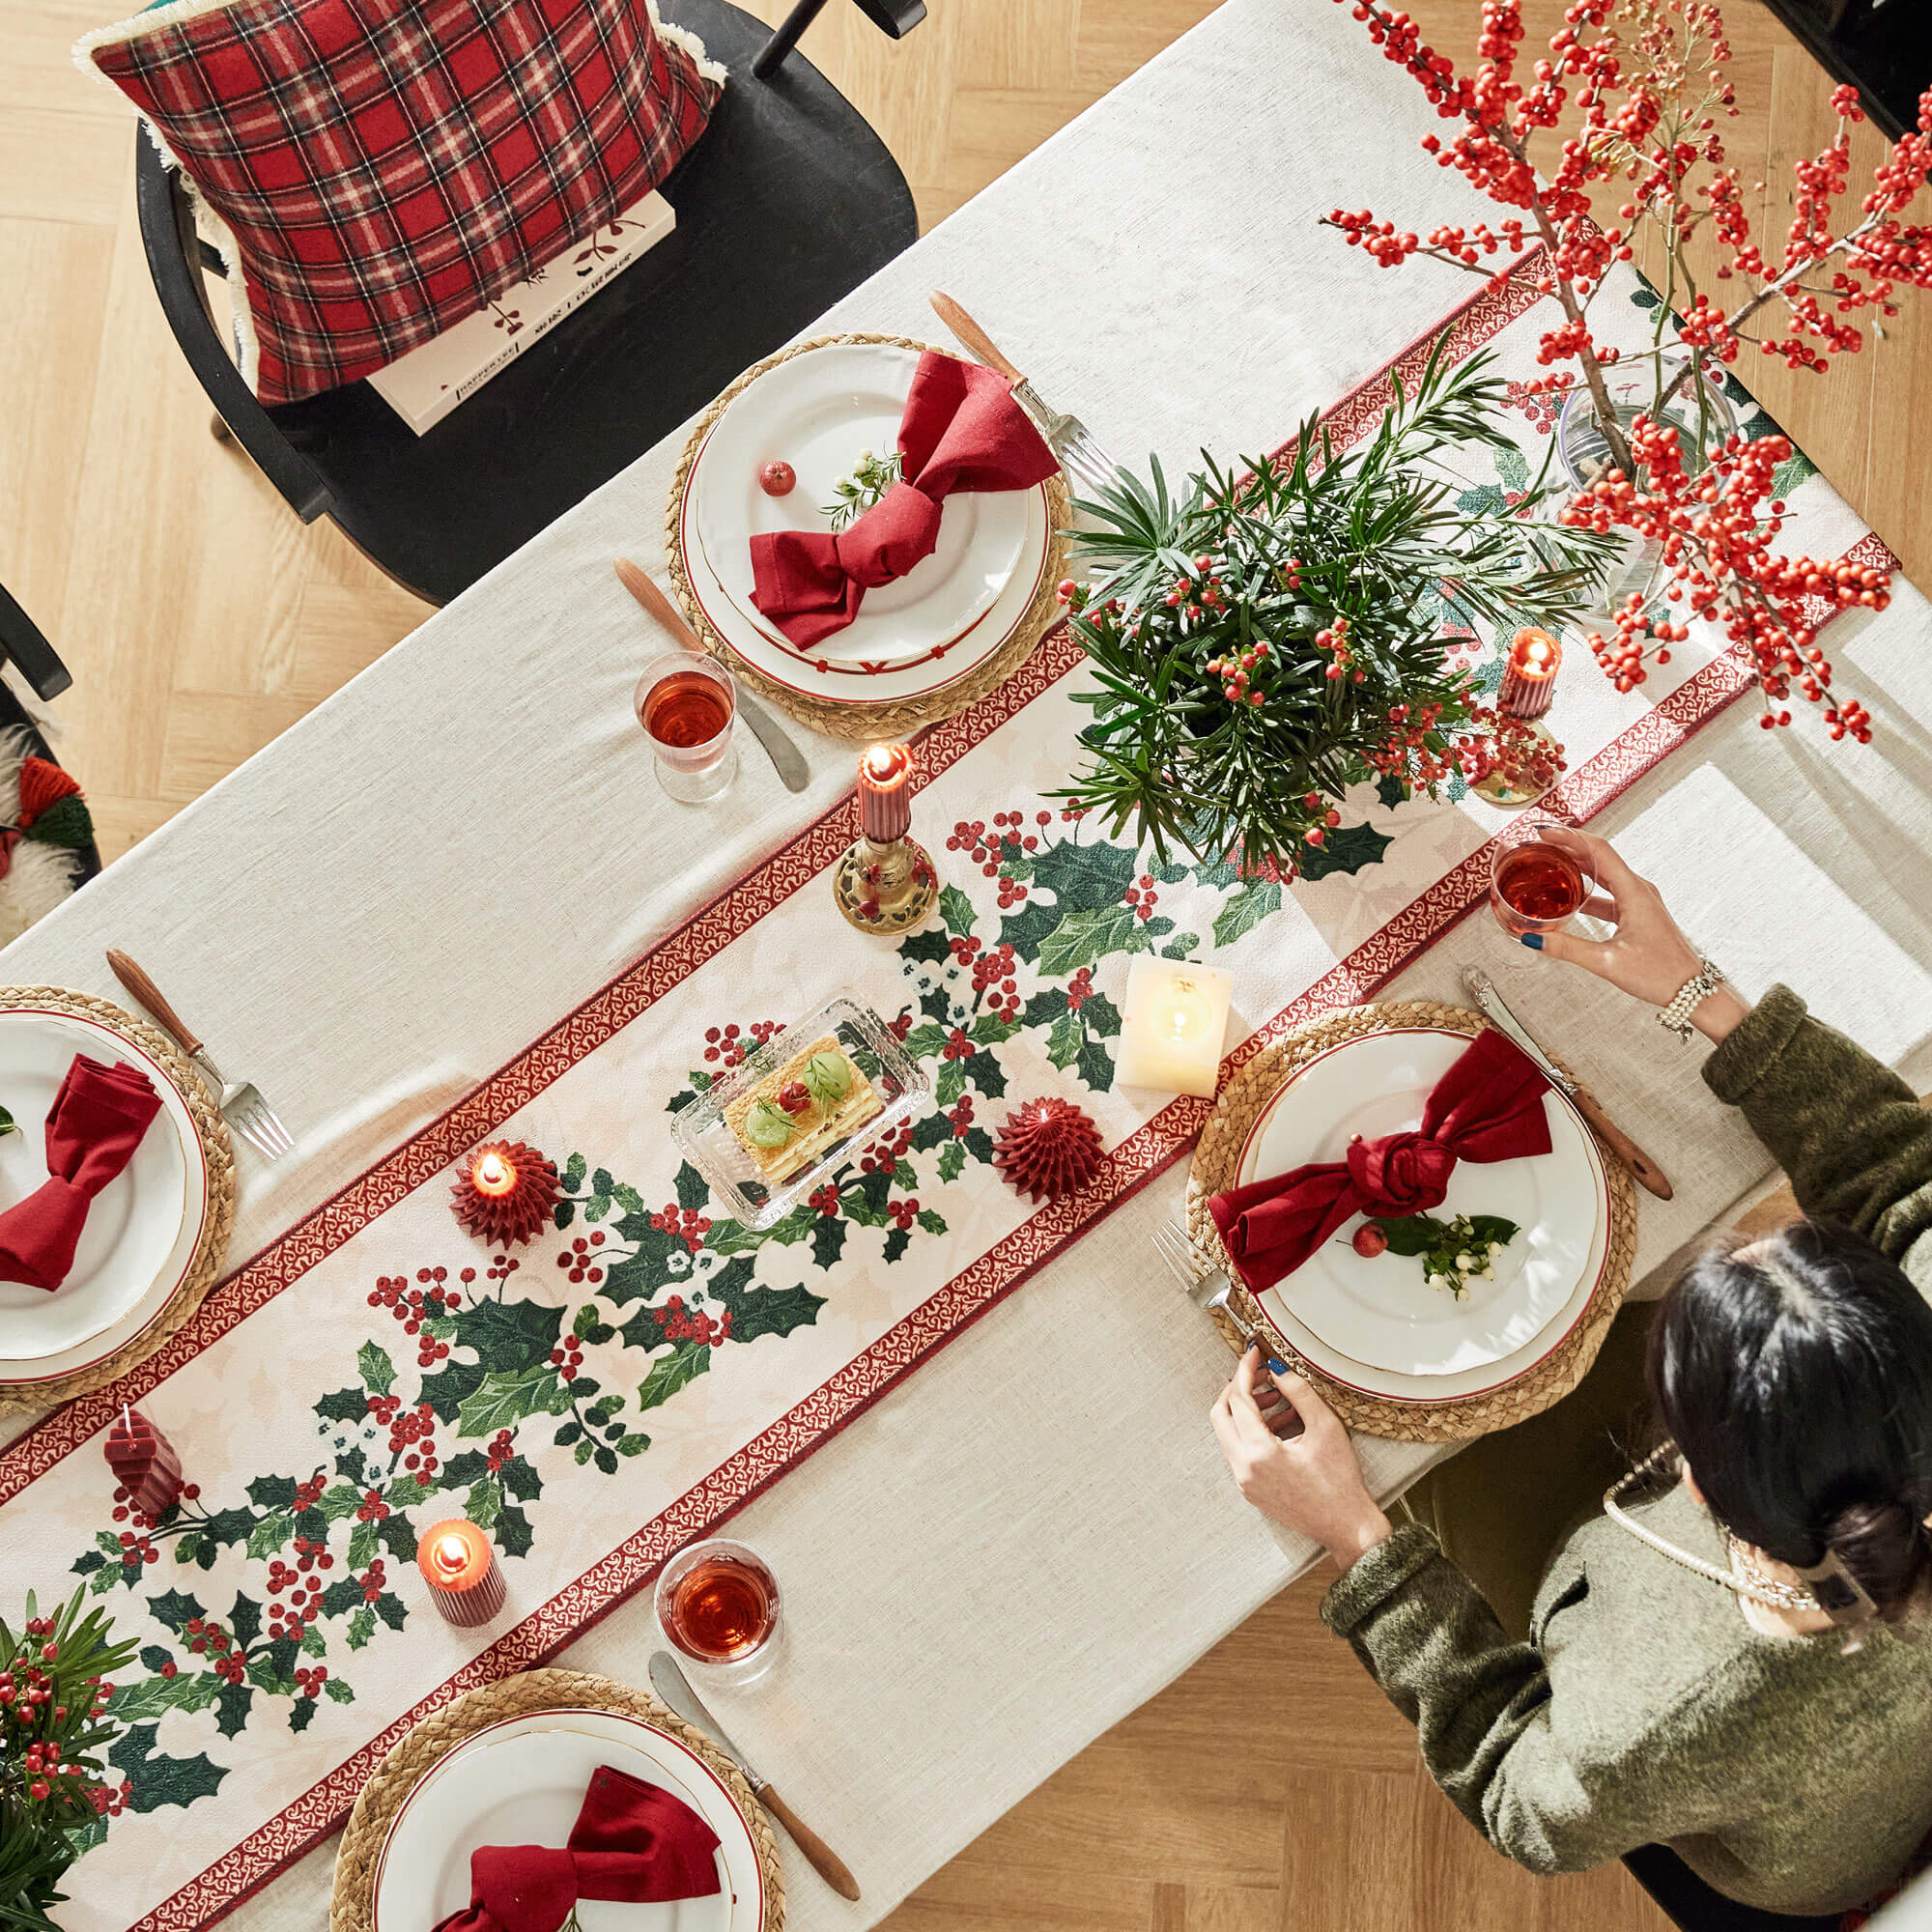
1648, 1221, 1932, 1617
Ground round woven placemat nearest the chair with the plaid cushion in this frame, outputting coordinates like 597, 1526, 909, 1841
665, 334, 1072, 740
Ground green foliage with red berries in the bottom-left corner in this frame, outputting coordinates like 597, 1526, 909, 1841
0, 1590, 133, 1932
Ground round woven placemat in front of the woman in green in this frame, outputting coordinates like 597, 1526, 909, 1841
1188, 1001, 1636, 1443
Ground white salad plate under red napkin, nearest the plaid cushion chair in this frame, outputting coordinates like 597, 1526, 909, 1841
692, 342, 1032, 668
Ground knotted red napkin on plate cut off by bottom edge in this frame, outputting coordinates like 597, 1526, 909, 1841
435, 1764, 719, 1932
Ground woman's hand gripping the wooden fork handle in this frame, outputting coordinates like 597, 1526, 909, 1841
1209, 1349, 1389, 1569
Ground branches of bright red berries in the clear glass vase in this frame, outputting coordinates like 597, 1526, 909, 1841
1327, 0, 1932, 742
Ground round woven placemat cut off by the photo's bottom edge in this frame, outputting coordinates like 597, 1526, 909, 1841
328, 1671, 784, 1932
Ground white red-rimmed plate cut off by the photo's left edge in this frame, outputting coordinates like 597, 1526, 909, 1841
0, 1007, 209, 1385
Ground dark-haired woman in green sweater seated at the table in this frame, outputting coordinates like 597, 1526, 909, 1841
1213, 833, 1932, 1913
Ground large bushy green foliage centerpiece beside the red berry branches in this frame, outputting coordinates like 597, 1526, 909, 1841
1065, 350, 1613, 877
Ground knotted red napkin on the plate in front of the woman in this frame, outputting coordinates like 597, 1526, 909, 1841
1208, 1028, 1549, 1291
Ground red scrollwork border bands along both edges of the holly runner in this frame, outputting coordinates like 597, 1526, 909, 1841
0, 255, 1895, 1932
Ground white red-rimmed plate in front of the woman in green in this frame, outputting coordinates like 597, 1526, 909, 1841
1238, 1028, 1609, 1401
